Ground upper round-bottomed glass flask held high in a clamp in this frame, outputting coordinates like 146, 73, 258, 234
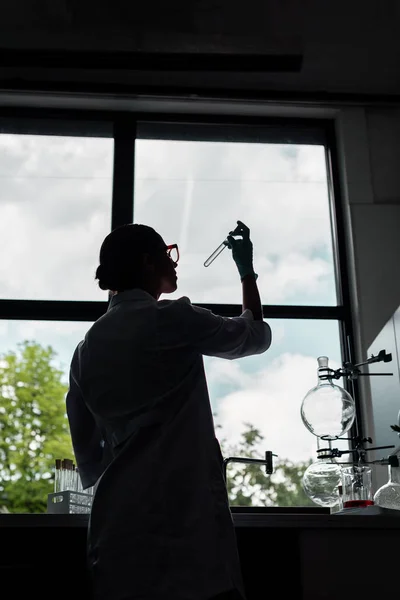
300, 356, 356, 439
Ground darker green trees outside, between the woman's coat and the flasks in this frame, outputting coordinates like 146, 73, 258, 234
217, 423, 315, 506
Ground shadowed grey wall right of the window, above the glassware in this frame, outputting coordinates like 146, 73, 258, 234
338, 108, 400, 356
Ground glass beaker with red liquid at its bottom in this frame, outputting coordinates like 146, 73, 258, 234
342, 464, 374, 508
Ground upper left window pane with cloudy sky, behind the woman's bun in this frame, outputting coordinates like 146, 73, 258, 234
0, 134, 114, 300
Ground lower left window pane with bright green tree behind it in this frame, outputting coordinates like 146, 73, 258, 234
0, 320, 90, 513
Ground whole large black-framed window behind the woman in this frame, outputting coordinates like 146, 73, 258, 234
0, 112, 351, 512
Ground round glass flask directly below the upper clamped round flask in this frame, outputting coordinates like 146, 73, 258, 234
302, 440, 342, 508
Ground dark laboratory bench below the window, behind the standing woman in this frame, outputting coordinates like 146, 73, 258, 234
0, 507, 400, 600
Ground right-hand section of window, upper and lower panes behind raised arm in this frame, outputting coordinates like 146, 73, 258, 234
134, 122, 354, 505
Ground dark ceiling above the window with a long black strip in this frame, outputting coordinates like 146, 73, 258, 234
0, 0, 400, 99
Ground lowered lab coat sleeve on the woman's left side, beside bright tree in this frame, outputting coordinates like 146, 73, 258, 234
66, 346, 108, 489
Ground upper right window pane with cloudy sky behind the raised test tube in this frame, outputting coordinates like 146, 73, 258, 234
134, 139, 337, 305
